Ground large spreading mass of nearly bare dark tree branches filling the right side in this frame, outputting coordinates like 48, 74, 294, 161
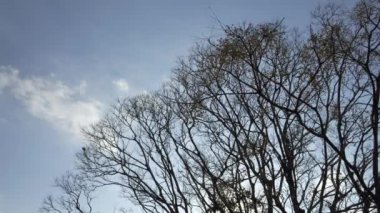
41, 0, 380, 213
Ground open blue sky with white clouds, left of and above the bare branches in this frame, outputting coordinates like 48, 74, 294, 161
0, 0, 353, 213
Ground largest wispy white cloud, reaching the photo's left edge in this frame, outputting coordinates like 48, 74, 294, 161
0, 66, 102, 135
